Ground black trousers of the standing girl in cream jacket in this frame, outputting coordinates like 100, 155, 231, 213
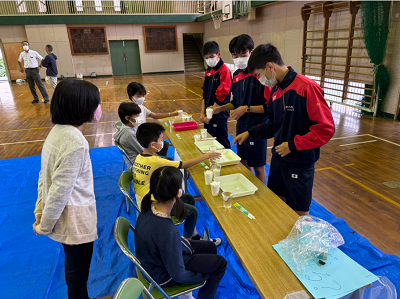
63, 242, 93, 299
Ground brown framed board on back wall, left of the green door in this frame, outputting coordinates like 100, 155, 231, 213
68, 27, 109, 55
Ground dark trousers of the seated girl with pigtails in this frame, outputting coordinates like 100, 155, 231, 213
164, 240, 227, 299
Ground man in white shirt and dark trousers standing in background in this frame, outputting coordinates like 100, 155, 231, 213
18, 41, 49, 104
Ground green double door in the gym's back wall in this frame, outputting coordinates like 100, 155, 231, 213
110, 40, 142, 76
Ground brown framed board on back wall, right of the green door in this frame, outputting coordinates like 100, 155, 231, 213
143, 26, 178, 53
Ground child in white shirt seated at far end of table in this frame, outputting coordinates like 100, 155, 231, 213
126, 82, 178, 157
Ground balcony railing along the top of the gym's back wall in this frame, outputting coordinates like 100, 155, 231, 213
0, 0, 200, 16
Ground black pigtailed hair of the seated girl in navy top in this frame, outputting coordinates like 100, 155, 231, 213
141, 166, 187, 219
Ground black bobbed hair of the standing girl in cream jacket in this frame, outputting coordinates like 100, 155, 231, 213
50, 79, 101, 126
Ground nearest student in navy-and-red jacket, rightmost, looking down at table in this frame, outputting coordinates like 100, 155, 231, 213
233, 44, 335, 215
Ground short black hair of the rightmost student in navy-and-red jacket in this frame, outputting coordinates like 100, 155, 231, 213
247, 44, 285, 73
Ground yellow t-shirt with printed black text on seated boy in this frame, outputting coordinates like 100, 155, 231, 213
132, 154, 182, 208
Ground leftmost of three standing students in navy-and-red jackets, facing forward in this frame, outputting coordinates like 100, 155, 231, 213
200, 41, 232, 148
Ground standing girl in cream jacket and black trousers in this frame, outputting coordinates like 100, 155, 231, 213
33, 80, 112, 299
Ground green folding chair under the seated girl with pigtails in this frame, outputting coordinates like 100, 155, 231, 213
114, 217, 206, 299
